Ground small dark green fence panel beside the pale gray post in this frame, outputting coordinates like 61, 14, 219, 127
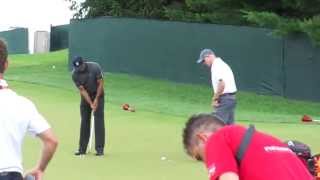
50, 25, 69, 51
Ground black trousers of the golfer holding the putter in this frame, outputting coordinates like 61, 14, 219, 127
79, 95, 105, 153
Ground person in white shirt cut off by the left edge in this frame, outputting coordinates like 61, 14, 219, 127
0, 39, 58, 180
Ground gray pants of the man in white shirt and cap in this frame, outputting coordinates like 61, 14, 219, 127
215, 95, 237, 125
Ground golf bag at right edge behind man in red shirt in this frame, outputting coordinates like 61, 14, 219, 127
285, 140, 320, 177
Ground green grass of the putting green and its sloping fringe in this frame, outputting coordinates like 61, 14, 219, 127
6, 51, 320, 180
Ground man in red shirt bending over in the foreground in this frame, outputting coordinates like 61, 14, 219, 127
183, 114, 313, 180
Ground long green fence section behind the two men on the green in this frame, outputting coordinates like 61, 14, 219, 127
69, 17, 283, 95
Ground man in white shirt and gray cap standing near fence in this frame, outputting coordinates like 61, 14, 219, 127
197, 49, 237, 124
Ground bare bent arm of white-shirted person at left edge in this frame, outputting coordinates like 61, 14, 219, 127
28, 129, 58, 180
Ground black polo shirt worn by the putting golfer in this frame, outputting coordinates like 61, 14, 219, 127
72, 62, 103, 95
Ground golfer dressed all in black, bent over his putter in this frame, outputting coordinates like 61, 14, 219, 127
72, 56, 105, 156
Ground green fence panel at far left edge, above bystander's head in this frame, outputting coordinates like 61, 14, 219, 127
0, 28, 29, 54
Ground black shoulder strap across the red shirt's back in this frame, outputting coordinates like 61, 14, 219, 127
236, 124, 255, 166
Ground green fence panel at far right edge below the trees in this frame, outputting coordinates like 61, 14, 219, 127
284, 36, 320, 101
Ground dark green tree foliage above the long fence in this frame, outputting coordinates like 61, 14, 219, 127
67, 0, 320, 44
